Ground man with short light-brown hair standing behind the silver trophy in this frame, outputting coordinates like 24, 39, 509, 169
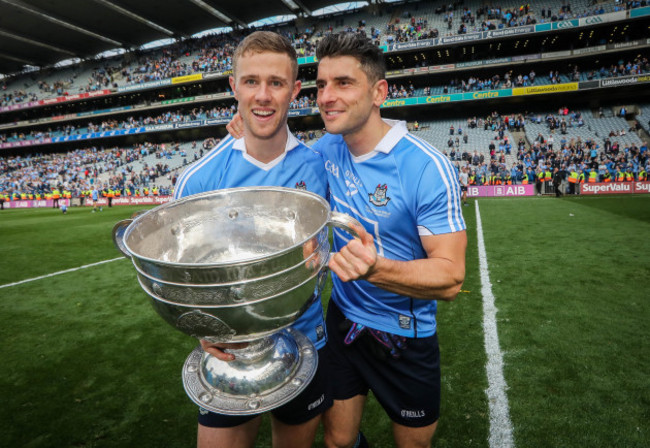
174, 31, 332, 448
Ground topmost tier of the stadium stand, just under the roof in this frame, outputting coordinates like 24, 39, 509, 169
1, 0, 642, 105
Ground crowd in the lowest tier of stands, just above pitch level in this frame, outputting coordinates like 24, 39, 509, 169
0, 103, 650, 203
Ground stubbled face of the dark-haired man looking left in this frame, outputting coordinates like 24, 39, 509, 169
316, 56, 388, 137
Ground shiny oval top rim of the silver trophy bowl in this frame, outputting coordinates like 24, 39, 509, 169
122, 187, 331, 269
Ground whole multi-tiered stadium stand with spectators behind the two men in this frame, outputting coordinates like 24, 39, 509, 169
0, 0, 650, 203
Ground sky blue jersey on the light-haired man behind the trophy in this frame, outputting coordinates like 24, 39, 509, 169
174, 133, 327, 349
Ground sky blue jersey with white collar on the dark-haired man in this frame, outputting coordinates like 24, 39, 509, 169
313, 120, 465, 337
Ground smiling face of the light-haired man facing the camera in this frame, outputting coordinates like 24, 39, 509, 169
230, 51, 300, 150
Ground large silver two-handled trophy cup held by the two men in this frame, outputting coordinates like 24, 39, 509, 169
113, 187, 358, 415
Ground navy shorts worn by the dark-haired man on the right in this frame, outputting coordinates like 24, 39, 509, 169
326, 300, 440, 427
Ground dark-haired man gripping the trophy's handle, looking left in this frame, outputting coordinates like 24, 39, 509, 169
314, 34, 467, 448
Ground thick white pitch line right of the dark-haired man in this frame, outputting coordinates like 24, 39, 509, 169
475, 200, 515, 448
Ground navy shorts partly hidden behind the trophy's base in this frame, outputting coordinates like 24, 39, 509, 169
199, 348, 333, 428
